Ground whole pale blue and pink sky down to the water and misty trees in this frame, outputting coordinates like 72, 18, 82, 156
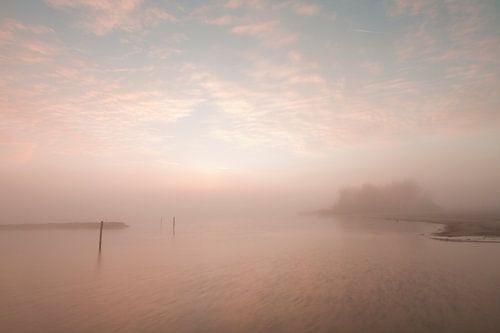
0, 0, 500, 223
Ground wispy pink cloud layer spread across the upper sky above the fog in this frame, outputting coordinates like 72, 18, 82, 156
0, 0, 500, 163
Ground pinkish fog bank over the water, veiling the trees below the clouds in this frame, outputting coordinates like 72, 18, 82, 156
0, 128, 500, 223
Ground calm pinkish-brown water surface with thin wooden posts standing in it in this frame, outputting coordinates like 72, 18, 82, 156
0, 219, 500, 333
